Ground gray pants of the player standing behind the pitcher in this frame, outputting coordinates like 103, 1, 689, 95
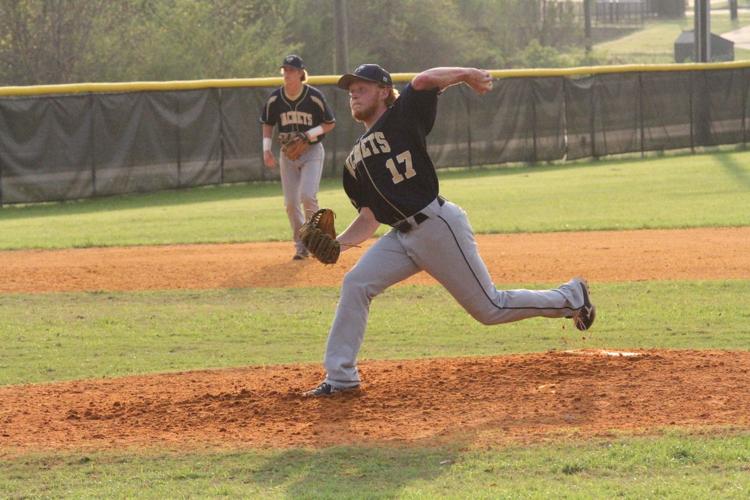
279, 143, 325, 253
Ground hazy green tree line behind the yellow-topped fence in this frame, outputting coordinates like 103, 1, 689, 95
0, 0, 596, 85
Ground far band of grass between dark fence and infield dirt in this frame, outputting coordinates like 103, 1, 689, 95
0, 151, 750, 249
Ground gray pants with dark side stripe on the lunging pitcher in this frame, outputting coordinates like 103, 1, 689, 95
325, 200, 583, 388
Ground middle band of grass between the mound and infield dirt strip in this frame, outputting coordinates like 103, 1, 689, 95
0, 280, 750, 385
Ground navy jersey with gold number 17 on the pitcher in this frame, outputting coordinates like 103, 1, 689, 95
344, 84, 439, 225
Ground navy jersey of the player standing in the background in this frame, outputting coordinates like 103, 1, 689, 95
260, 84, 336, 142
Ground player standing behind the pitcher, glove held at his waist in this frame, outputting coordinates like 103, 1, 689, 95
260, 54, 336, 260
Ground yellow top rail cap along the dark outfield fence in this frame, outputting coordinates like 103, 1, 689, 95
0, 61, 750, 97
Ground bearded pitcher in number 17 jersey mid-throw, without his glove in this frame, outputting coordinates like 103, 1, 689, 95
305, 64, 595, 396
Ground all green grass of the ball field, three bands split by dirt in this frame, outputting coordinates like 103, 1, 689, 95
0, 152, 750, 499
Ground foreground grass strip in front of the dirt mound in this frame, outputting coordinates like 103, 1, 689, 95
0, 433, 750, 499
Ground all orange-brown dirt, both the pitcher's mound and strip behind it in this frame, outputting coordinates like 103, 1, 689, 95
0, 228, 750, 455
